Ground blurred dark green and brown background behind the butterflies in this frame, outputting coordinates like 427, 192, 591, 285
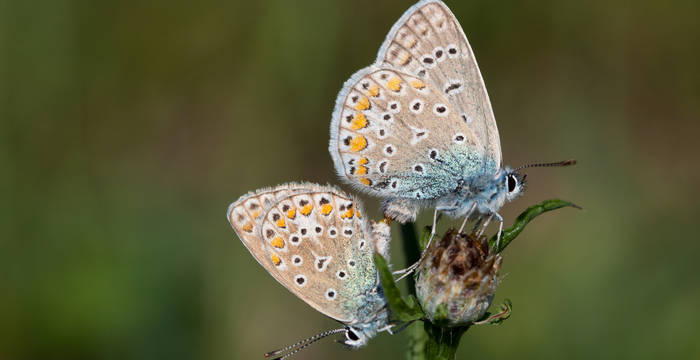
0, 0, 700, 360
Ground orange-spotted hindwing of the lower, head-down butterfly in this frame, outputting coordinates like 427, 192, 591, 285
261, 186, 377, 323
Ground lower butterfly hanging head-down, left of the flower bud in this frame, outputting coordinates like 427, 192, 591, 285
226, 183, 391, 358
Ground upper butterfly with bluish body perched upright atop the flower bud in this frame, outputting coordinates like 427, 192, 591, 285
329, 0, 571, 245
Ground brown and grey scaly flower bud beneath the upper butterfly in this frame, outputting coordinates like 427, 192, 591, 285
416, 229, 503, 326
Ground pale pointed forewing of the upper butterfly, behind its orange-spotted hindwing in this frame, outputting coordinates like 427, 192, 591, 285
376, 0, 501, 167
